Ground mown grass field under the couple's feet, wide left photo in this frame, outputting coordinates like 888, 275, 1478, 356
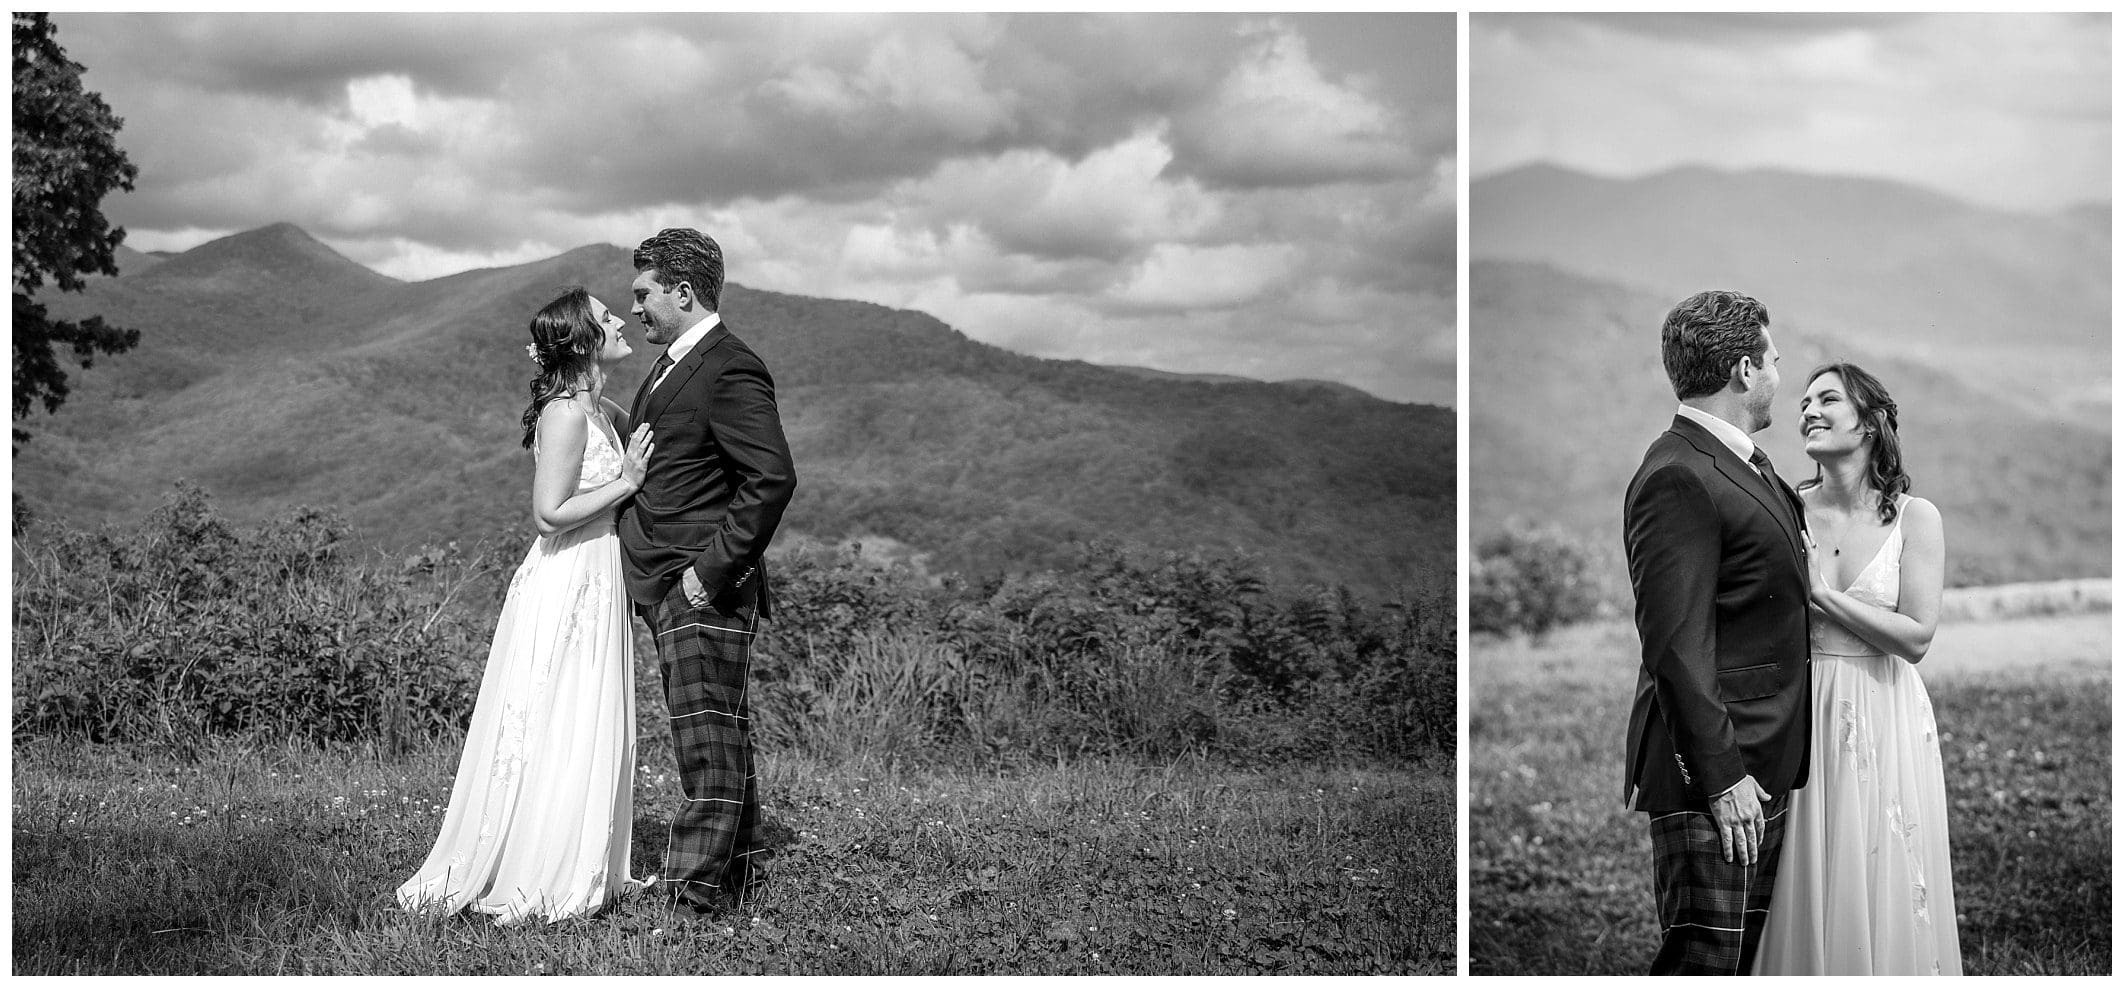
13, 737, 1455, 975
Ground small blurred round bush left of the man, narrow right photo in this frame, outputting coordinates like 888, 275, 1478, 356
1468, 518, 1599, 637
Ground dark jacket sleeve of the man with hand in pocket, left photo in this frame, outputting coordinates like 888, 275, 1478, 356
692, 353, 797, 597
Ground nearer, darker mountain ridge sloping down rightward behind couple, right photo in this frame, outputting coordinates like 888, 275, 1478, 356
1466, 261, 2111, 590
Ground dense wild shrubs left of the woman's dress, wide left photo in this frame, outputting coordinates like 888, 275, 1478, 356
13, 484, 491, 746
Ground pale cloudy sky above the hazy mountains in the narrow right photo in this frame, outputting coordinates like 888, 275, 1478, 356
1468, 13, 2109, 210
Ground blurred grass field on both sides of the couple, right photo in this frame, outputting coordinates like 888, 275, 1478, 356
1468, 614, 2111, 975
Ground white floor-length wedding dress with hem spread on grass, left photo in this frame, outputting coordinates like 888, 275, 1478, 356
397, 401, 637, 924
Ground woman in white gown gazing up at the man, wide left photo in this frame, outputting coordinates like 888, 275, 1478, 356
397, 289, 652, 924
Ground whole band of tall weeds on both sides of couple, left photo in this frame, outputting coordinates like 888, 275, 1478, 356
13, 484, 1455, 761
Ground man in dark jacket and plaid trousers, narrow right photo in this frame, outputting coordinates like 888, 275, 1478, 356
1623, 291, 1810, 975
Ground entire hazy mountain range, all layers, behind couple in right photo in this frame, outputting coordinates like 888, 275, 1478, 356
1468, 166, 2111, 599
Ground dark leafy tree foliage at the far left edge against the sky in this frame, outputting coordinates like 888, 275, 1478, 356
13, 13, 140, 444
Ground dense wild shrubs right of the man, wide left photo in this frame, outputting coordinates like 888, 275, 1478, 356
754, 544, 1457, 761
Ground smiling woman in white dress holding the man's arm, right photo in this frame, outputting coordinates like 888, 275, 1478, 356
1754, 363, 1963, 975
